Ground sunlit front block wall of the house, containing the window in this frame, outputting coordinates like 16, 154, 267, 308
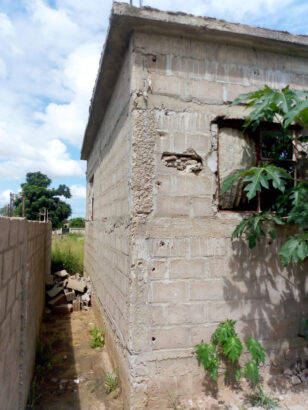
132, 33, 308, 409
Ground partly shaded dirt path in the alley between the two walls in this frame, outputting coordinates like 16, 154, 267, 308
28, 308, 123, 410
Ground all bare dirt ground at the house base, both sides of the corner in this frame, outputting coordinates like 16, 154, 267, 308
27, 308, 308, 410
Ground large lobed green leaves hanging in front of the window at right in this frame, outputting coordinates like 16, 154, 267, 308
221, 86, 308, 266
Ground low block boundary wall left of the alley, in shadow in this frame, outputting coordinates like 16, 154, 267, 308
0, 217, 51, 410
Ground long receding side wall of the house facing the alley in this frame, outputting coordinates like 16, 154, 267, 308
84, 45, 131, 400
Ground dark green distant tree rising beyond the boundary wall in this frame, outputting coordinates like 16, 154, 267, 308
15, 172, 72, 229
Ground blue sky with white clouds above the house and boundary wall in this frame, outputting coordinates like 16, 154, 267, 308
0, 0, 308, 217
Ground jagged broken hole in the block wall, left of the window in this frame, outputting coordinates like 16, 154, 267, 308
161, 148, 203, 174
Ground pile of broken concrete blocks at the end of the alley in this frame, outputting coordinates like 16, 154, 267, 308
46, 270, 91, 313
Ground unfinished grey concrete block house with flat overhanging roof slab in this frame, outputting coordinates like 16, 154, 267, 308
82, 3, 308, 409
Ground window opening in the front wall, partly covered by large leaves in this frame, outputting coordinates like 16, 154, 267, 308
218, 123, 298, 212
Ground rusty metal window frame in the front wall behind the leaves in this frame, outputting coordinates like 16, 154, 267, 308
217, 119, 300, 214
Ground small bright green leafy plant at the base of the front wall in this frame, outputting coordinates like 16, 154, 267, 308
195, 320, 265, 385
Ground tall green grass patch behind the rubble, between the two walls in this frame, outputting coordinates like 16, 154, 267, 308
51, 233, 84, 275
